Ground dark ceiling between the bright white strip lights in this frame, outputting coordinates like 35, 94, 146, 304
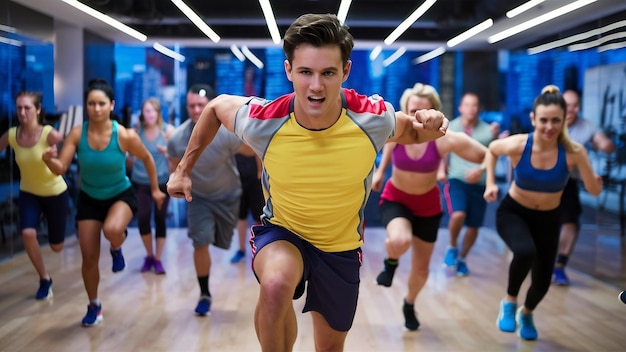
11, 0, 626, 50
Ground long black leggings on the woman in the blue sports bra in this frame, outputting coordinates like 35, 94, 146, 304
496, 194, 560, 310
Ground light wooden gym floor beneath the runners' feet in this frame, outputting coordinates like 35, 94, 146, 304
0, 228, 626, 352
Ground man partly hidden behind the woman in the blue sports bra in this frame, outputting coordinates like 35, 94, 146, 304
554, 90, 615, 286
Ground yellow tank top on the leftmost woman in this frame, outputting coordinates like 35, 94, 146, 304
9, 125, 67, 197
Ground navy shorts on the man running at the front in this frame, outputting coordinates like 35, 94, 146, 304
250, 224, 363, 331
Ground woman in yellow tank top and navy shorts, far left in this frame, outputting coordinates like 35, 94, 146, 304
0, 92, 69, 299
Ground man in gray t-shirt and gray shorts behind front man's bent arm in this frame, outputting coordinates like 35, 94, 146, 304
167, 85, 256, 316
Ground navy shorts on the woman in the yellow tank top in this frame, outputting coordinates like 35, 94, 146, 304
18, 190, 70, 244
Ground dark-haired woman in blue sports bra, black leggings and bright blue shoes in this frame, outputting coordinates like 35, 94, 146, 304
484, 85, 602, 340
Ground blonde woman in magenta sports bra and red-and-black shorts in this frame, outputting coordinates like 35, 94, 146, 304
372, 83, 487, 330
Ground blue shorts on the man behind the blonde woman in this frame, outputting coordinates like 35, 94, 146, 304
443, 179, 487, 227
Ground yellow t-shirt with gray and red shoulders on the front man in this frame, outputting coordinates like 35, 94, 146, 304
235, 90, 395, 252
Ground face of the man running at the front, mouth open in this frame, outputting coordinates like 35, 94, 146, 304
285, 44, 351, 123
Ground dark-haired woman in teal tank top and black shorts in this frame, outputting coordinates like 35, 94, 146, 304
44, 80, 165, 326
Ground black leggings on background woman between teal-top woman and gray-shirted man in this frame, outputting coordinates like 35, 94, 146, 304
133, 183, 170, 238
